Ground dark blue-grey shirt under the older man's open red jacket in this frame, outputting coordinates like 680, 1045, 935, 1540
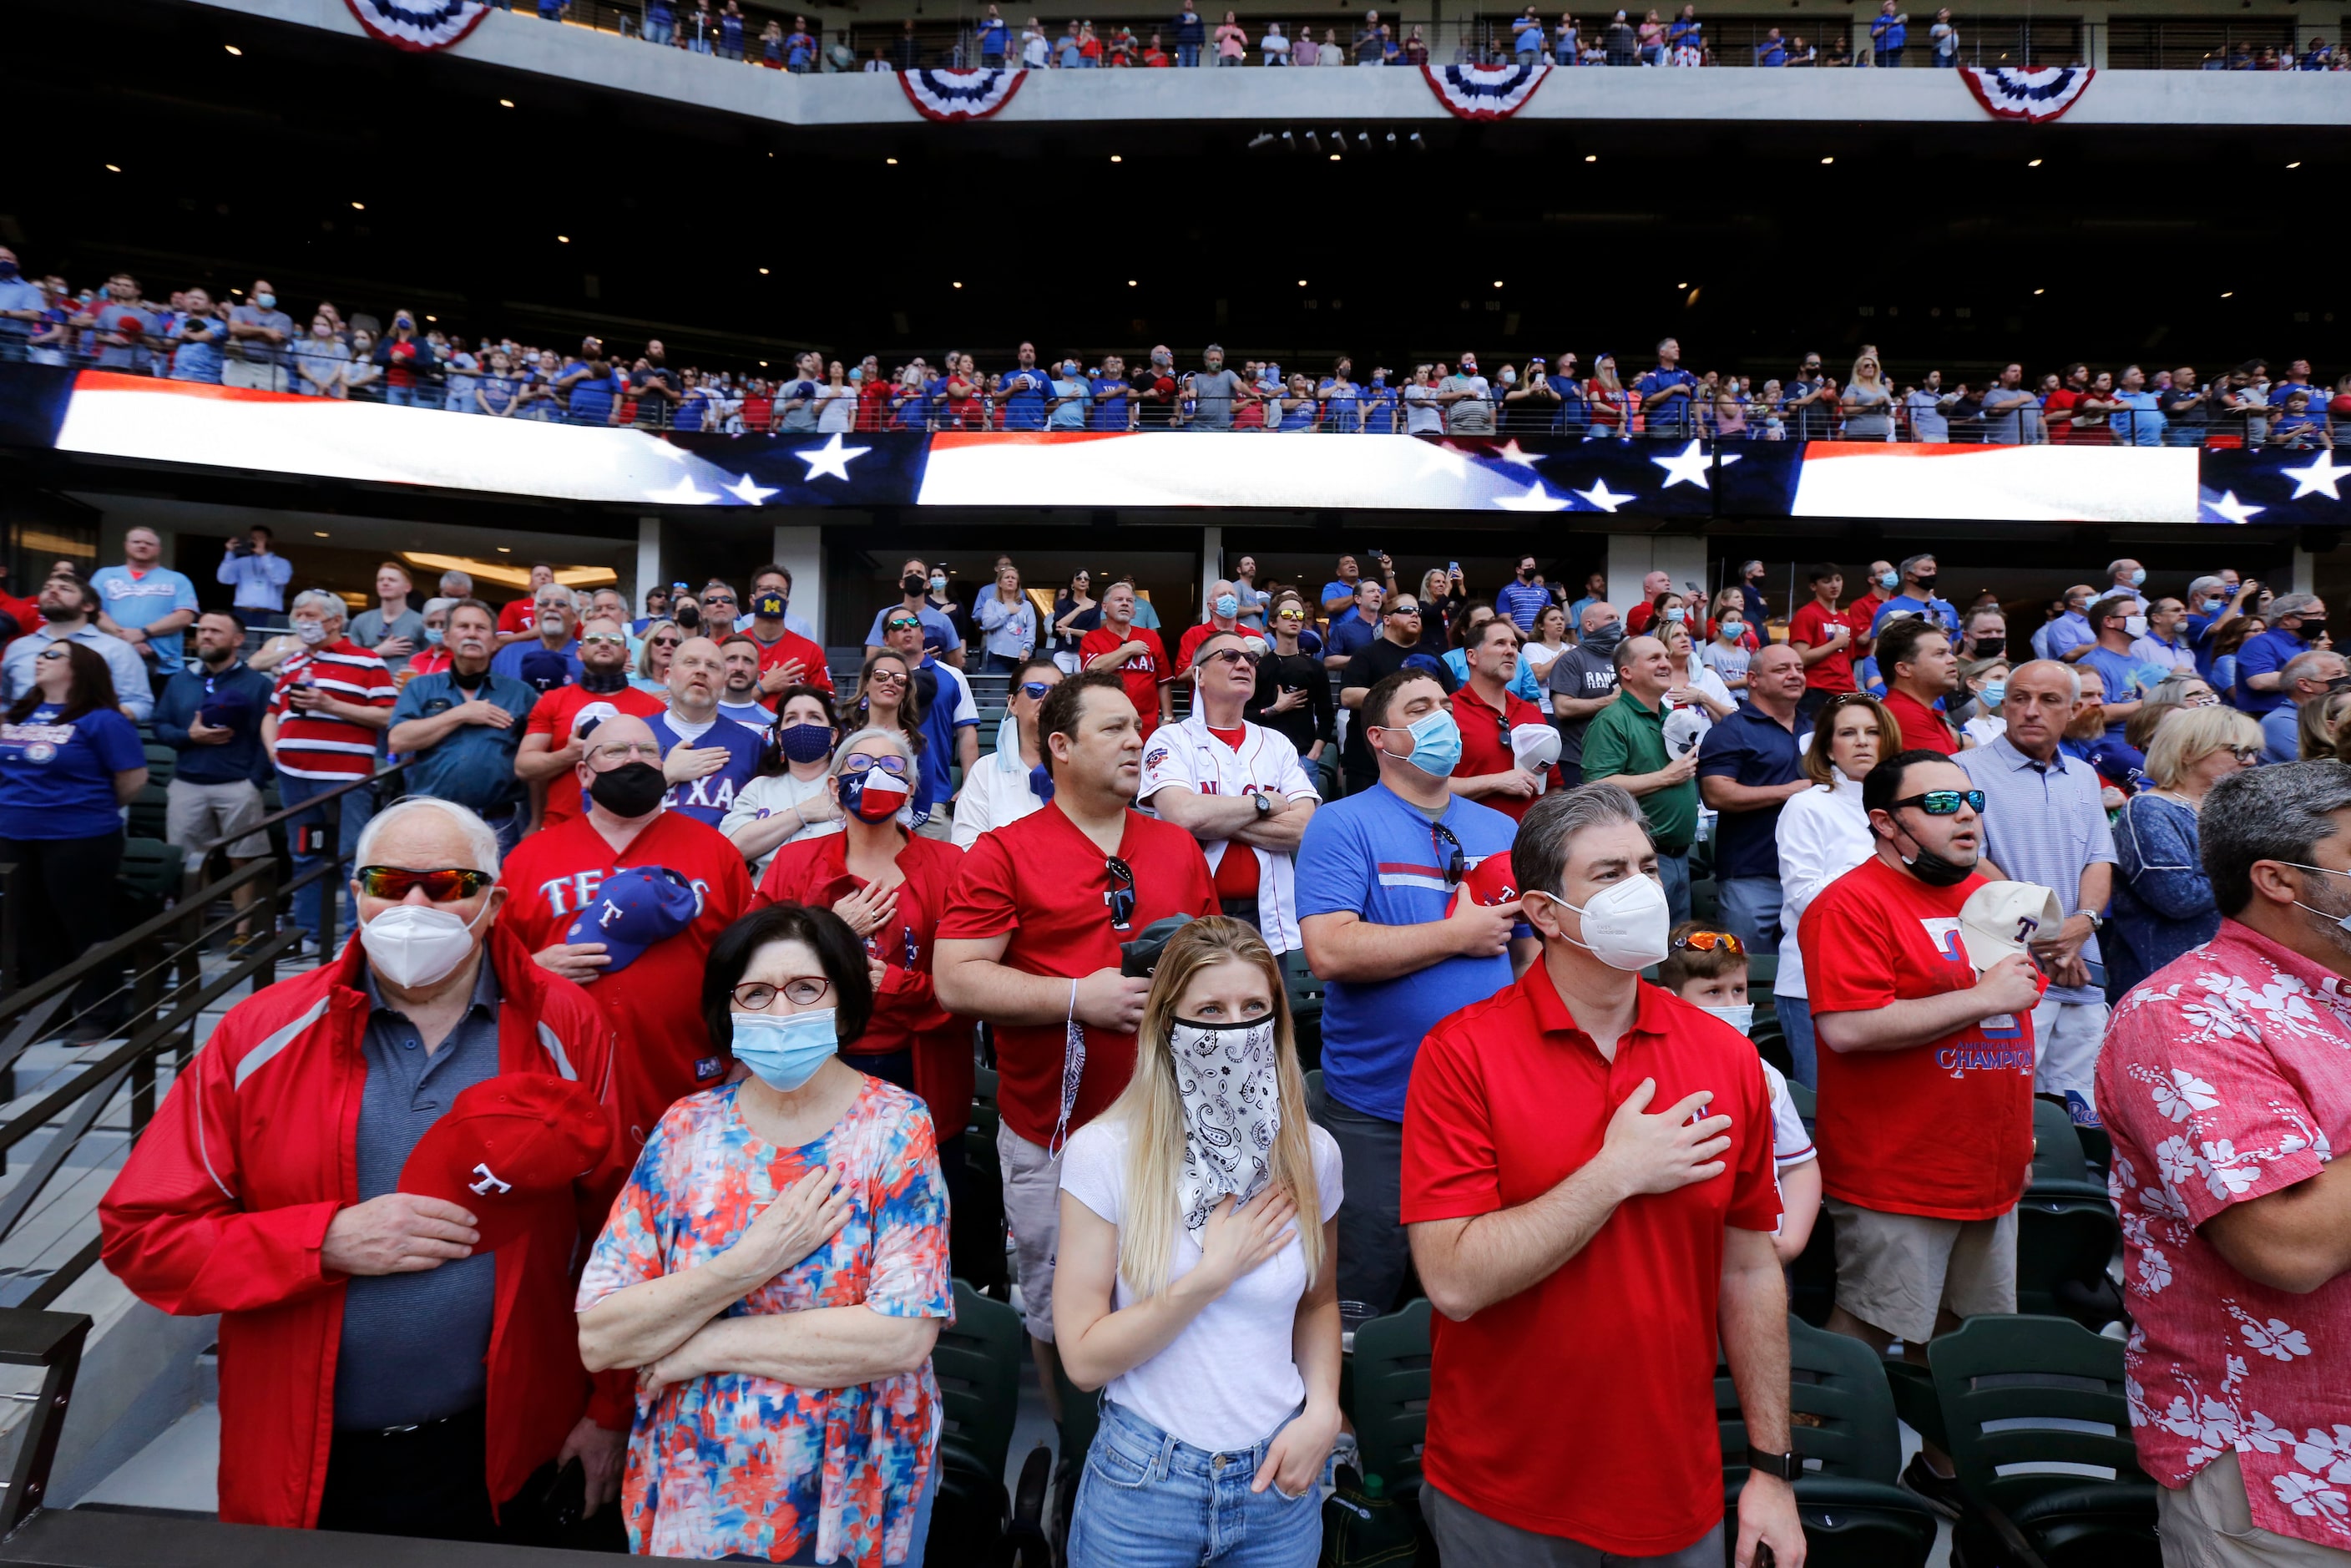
334, 959, 498, 1432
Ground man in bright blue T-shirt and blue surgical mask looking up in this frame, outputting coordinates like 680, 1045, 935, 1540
1297, 670, 1538, 1312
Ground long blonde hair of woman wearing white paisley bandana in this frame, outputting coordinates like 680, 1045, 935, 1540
1103, 914, 1323, 1300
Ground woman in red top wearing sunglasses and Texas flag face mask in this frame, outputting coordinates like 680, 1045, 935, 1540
752, 729, 973, 1192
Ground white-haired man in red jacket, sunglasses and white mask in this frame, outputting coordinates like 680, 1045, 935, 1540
99, 797, 633, 1540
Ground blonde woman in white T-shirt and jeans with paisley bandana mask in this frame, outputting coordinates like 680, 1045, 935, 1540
1054, 917, 1340, 1568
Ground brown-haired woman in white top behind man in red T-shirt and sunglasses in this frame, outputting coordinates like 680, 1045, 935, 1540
1770, 691, 1902, 1089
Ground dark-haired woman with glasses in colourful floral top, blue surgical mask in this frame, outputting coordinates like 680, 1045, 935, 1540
579, 903, 949, 1565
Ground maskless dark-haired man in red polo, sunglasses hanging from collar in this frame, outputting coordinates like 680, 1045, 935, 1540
931, 670, 1218, 1401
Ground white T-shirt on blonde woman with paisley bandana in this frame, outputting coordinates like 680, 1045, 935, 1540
1060, 1116, 1340, 1453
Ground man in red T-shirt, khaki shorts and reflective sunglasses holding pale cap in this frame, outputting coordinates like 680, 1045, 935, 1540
1796, 750, 2045, 1505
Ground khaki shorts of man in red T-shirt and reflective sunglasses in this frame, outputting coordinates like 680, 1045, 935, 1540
1824, 1199, 2017, 1345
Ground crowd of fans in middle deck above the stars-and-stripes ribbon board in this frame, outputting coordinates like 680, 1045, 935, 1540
0, 266, 2351, 449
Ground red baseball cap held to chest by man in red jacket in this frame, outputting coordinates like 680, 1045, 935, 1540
400, 1072, 611, 1253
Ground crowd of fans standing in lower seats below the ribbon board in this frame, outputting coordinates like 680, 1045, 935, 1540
0, 512, 2351, 1568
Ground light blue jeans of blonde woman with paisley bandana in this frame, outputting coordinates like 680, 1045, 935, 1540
1069, 1399, 1322, 1568
